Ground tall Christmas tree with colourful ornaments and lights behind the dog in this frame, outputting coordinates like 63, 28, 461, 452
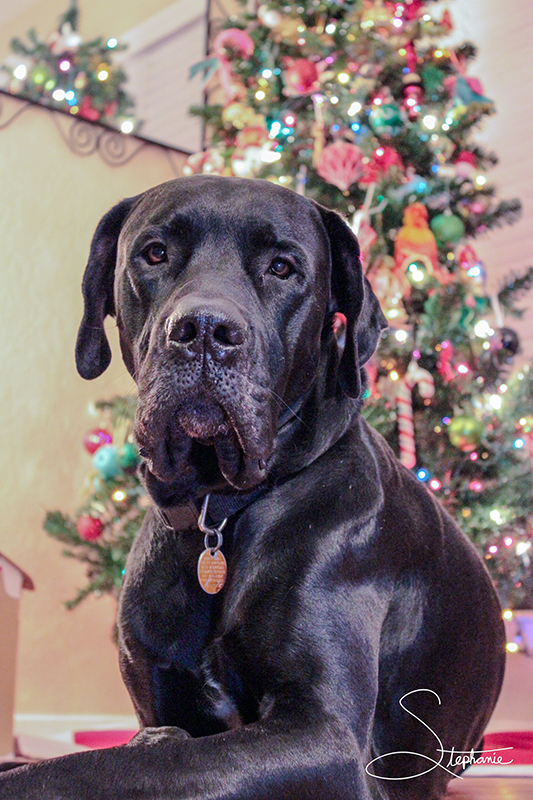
47, 0, 533, 608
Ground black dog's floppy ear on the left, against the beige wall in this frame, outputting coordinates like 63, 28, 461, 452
76, 197, 138, 380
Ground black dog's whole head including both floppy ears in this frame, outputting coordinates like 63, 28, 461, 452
76, 176, 386, 505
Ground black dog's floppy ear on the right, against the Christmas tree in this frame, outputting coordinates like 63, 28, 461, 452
318, 206, 387, 397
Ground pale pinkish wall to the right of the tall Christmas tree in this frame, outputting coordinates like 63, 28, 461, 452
442, 0, 533, 361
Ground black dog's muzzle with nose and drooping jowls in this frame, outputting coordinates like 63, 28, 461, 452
136, 293, 277, 489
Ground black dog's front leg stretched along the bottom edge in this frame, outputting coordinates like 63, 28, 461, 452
0, 715, 379, 800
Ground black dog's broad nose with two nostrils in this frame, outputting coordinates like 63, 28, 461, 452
166, 295, 249, 360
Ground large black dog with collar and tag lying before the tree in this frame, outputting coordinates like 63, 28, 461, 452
0, 177, 504, 800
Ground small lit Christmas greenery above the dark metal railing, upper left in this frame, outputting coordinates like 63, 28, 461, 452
0, 0, 138, 133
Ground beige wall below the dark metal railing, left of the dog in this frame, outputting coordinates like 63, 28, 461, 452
0, 94, 185, 714
